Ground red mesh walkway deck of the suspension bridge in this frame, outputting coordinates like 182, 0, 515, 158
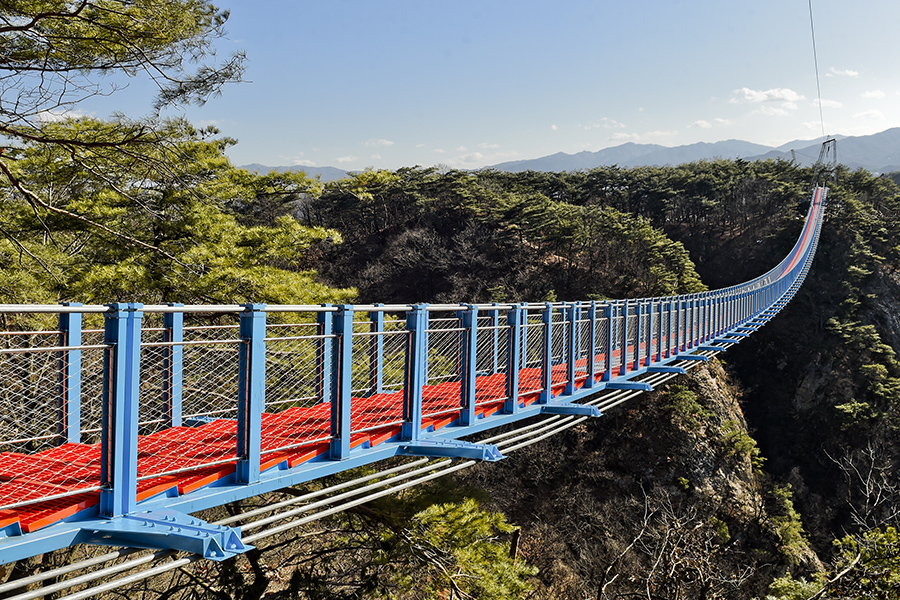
0, 352, 648, 533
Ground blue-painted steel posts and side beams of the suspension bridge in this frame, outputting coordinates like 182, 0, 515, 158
0, 190, 824, 562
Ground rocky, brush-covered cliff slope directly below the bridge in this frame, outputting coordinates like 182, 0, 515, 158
459, 361, 818, 599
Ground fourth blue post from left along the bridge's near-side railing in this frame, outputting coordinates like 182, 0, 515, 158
401, 304, 428, 440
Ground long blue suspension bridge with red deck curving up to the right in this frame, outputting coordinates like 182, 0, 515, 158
0, 175, 827, 584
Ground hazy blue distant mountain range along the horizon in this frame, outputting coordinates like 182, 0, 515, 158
241, 127, 900, 181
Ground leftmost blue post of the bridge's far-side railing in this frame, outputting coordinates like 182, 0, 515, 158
57, 302, 81, 444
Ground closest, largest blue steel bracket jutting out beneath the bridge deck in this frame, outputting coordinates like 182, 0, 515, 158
83, 510, 253, 561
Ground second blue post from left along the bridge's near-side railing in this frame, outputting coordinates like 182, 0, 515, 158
235, 304, 266, 483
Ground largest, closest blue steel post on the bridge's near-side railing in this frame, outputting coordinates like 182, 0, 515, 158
99, 303, 143, 517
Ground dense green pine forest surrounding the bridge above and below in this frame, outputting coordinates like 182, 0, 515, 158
0, 0, 900, 600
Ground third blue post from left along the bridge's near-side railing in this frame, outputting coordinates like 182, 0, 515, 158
330, 304, 354, 460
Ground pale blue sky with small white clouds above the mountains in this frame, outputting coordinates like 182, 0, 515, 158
82, 0, 900, 169
